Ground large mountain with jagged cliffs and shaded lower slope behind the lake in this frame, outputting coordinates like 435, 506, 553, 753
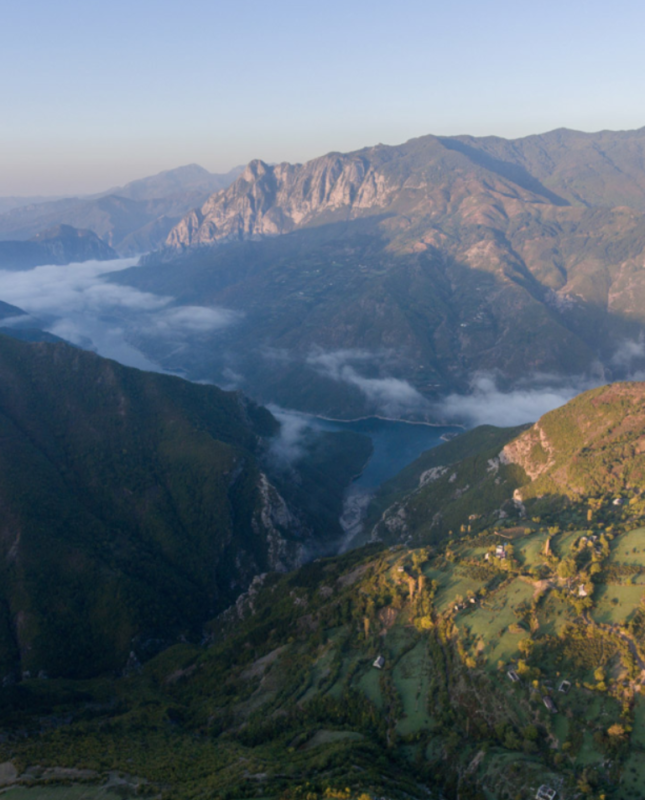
105, 130, 645, 419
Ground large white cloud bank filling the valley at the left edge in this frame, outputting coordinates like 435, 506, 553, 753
0, 258, 241, 371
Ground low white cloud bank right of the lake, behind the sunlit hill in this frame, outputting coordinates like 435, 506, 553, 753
436, 375, 592, 428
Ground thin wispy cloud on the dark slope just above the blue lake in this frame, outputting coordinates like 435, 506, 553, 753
306, 350, 428, 417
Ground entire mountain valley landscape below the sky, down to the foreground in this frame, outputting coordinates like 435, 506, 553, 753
6, 130, 645, 800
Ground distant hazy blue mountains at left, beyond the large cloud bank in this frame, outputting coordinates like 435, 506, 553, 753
0, 164, 239, 255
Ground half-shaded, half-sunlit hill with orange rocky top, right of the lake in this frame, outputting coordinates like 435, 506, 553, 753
364, 383, 645, 545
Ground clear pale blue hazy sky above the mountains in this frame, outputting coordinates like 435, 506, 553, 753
5, 0, 645, 195
